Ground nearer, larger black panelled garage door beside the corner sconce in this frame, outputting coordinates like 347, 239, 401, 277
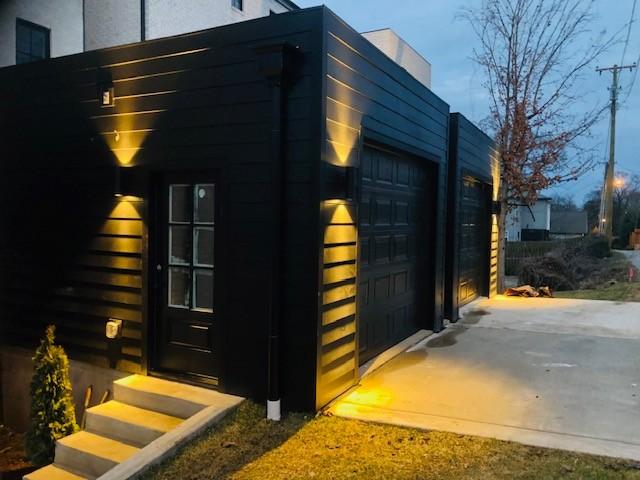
358, 147, 433, 363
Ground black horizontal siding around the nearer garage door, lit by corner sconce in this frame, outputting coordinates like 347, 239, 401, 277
316, 9, 449, 408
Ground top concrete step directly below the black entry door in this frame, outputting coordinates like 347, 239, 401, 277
113, 375, 242, 418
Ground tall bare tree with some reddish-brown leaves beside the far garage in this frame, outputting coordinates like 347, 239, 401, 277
463, 0, 611, 289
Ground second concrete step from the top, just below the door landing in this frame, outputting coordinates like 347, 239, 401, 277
86, 400, 182, 447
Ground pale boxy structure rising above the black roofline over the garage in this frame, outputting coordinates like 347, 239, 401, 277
361, 28, 431, 88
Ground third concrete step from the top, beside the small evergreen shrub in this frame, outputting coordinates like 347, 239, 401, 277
55, 432, 139, 477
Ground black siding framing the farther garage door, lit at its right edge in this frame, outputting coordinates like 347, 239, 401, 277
445, 113, 500, 321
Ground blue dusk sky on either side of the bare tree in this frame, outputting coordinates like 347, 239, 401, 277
296, 0, 640, 204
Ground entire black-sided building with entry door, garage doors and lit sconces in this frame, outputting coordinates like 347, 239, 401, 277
0, 7, 497, 410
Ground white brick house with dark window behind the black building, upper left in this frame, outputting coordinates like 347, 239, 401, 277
0, 0, 298, 67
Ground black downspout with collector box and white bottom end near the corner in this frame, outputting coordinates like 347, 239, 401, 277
254, 44, 294, 421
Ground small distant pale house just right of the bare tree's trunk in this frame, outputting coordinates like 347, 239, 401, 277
506, 197, 551, 242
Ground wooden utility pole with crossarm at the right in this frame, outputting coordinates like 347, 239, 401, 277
596, 63, 637, 244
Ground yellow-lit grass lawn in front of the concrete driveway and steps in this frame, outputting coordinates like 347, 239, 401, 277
143, 402, 640, 480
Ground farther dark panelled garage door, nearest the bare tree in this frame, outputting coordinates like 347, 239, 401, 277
458, 177, 489, 306
